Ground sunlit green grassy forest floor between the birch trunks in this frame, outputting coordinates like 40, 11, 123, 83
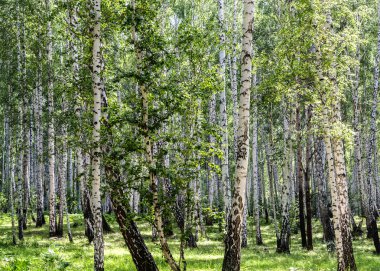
0, 215, 380, 271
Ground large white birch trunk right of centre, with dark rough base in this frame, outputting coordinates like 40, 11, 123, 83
222, 0, 254, 271
